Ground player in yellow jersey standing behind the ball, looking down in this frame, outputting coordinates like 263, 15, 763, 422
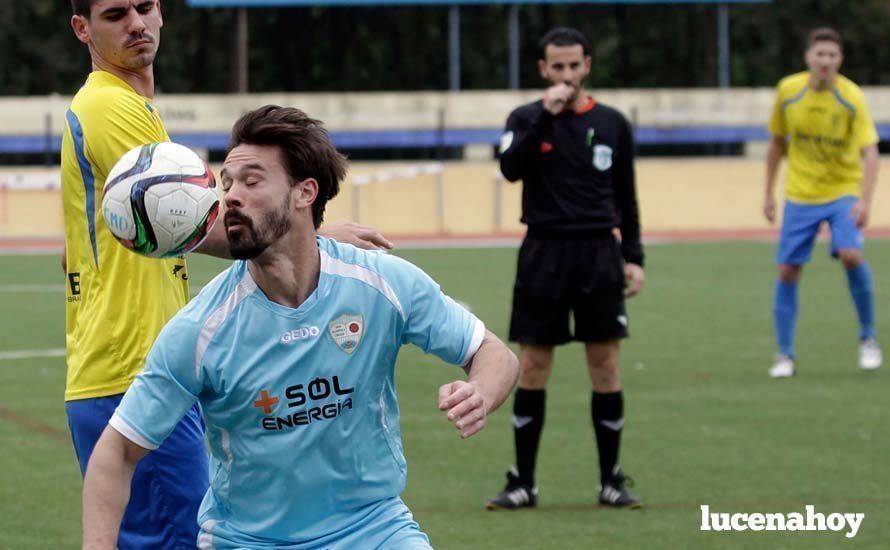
62, 0, 391, 549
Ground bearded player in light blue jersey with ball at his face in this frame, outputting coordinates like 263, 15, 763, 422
83, 106, 518, 549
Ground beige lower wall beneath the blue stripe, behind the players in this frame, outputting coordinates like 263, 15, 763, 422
0, 158, 890, 239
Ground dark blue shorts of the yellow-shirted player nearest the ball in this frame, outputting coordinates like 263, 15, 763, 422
65, 394, 209, 550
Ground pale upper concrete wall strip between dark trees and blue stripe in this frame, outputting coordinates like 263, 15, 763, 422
0, 87, 890, 136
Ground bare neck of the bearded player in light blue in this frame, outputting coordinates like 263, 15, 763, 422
247, 228, 321, 308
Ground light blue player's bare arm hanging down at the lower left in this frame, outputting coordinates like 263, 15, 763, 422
83, 426, 148, 550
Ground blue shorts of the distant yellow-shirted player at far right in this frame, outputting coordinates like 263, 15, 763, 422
776, 196, 865, 265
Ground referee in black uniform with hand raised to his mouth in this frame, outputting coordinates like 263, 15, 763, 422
486, 28, 643, 509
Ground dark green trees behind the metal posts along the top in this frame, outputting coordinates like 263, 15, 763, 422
0, 0, 890, 95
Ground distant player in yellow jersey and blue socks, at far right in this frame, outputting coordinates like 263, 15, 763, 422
763, 28, 882, 378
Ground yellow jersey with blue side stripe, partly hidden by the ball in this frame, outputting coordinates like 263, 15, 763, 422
62, 71, 188, 401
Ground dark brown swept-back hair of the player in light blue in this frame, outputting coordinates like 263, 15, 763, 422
228, 105, 347, 229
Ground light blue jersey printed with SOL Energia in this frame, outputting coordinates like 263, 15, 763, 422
110, 238, 485, 548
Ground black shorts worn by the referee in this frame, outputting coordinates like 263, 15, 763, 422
510, 233, 627, 346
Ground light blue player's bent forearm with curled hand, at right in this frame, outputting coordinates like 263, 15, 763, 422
439, 330, 519, 439
